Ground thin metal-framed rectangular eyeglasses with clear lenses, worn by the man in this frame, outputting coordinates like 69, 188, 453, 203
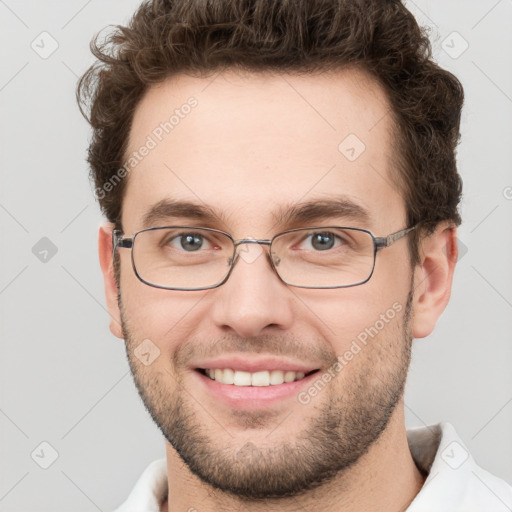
112, 226, 417, 291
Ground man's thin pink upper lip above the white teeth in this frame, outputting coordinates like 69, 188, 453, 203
192, 355, 320, 373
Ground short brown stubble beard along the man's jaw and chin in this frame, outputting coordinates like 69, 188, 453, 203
120, 290, 413, 501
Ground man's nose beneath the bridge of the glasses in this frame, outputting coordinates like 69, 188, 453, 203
211, 243, 293, 337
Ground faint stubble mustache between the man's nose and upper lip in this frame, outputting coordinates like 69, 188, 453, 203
172, 335, 337, 368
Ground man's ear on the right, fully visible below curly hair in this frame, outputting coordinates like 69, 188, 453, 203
412, 222, 458, 338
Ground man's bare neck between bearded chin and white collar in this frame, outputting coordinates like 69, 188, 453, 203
162, 402, 425, 512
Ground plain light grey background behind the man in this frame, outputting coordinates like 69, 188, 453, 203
0, 0, 512, 512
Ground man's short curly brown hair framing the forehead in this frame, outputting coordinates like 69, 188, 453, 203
77, 0, 464, 263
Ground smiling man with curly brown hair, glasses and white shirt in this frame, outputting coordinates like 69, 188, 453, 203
79, 0, 512, 512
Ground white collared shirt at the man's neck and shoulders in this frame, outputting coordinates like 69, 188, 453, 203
114, 423, 512, 512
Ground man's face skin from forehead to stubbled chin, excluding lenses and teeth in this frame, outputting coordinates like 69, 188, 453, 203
113, 71, 411, 498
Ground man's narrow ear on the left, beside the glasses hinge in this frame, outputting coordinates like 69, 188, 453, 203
98, 222, 124, 339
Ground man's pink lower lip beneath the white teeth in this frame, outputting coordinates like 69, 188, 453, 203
193, 370, 318, 410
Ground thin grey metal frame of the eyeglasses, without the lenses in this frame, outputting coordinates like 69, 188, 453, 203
112, 224, 419, 291
